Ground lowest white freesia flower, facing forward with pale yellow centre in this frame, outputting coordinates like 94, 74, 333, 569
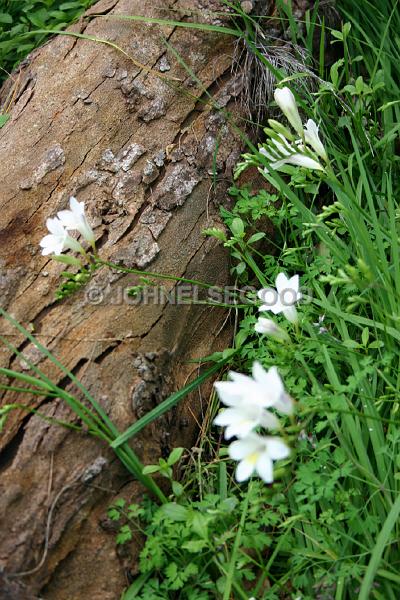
228, 433, 290, 483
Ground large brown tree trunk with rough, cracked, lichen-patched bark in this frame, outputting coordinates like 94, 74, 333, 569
0, 0, 241, 600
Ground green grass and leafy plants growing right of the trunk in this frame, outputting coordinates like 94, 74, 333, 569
115, 2, 400, 600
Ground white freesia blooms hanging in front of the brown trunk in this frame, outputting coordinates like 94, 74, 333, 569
40, 196, 95, 256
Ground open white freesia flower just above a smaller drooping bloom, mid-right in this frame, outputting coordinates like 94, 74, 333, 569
257, 273, 301, 323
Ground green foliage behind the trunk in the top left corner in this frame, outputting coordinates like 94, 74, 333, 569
0, 0, 95, 79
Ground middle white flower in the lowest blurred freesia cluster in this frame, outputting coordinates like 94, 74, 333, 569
214, 399, 279, 440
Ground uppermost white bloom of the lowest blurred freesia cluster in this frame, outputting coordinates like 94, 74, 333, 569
214, 361, 293, 414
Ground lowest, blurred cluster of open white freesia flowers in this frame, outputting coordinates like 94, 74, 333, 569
214, 362, 293, 483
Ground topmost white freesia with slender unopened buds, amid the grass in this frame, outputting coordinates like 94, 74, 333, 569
259, 87, 328, 171
